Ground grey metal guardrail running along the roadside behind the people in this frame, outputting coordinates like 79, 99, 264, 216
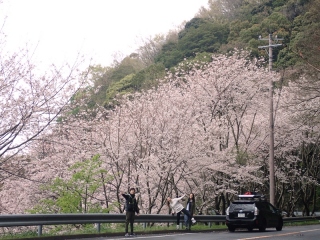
0, 213, 320, 236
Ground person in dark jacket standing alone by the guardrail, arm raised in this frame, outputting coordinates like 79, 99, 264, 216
122, 188, 139, 237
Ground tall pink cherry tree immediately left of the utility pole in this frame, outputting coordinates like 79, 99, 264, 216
168, 55, 276, 212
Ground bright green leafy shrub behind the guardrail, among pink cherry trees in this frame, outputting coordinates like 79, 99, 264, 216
29, 155, 111, 213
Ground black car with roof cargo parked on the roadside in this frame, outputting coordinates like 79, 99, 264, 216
226, 194, 283, 232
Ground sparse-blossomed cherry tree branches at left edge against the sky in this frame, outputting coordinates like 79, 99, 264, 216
0, 12, 87, 212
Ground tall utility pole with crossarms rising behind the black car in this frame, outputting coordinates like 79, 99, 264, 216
258, 34, 283, 205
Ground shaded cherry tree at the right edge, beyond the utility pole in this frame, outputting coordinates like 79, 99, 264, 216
276, 76, 320, 215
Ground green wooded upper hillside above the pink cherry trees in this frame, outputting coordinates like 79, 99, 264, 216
82, 0, 320, 107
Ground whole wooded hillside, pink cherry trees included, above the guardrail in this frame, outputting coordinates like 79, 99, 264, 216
0, 0, 320, 229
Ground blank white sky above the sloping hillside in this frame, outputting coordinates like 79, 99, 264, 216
0, 0, 208, 66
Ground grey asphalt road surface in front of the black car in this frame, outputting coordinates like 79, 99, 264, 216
74, 224, 320, 240
